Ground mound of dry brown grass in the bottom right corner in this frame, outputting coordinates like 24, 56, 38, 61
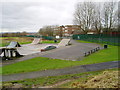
71, 71, 119, 88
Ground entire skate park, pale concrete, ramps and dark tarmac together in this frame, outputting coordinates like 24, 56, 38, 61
1, 38, 103, 65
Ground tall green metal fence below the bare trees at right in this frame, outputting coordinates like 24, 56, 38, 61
72, 34, 120, 46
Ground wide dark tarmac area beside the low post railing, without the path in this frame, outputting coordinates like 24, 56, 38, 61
41, 40, 103, 61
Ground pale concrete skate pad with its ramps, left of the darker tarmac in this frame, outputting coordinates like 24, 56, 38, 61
1, 38, 70, 56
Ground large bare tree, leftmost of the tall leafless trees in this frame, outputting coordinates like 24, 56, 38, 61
74, 2, 95, 33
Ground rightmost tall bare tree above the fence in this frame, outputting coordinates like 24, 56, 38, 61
103, 2, 118, 32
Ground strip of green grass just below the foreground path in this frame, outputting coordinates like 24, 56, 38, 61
3, 69, 118, 88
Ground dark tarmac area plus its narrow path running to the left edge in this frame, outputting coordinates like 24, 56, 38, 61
2, 40, 103, 66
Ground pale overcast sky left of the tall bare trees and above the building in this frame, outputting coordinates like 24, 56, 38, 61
0, 0, 119, 32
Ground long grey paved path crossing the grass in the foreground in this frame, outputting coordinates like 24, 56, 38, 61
2, 61, 120, 81
